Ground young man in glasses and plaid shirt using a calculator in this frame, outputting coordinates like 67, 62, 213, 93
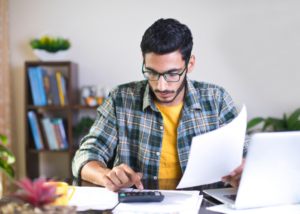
72, 19, 249, 191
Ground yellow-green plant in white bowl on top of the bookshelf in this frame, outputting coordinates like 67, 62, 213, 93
30, 35, 71, 61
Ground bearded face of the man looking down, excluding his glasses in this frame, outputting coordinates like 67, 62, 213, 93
145, 51, 190, 107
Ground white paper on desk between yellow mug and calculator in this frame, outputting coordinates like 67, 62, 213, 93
69, 187, 132, 211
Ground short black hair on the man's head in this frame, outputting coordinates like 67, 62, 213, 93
141, 19, 193, 63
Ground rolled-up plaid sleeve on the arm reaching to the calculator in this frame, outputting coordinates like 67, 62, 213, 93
72, 91, 118, 179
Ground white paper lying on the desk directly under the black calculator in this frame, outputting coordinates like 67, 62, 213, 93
113, 190, 202, 213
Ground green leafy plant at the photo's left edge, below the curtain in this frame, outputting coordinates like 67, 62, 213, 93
0, 134, 15, 179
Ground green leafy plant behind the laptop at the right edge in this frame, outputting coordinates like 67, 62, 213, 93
247, 108, 300, 134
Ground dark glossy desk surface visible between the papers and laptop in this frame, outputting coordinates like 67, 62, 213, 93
0, 179, 222, 214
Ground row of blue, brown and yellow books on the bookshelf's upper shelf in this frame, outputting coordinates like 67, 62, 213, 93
28, 67, 68, 106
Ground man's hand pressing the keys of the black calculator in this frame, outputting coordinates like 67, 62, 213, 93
101, 164, 144, 191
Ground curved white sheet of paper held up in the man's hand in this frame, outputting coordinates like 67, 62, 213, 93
177, 106, 247, 188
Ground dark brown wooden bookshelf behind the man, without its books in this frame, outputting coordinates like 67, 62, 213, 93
24, 61, 80, 179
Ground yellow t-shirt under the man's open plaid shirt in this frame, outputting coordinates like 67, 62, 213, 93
155, 102, 183, 179
